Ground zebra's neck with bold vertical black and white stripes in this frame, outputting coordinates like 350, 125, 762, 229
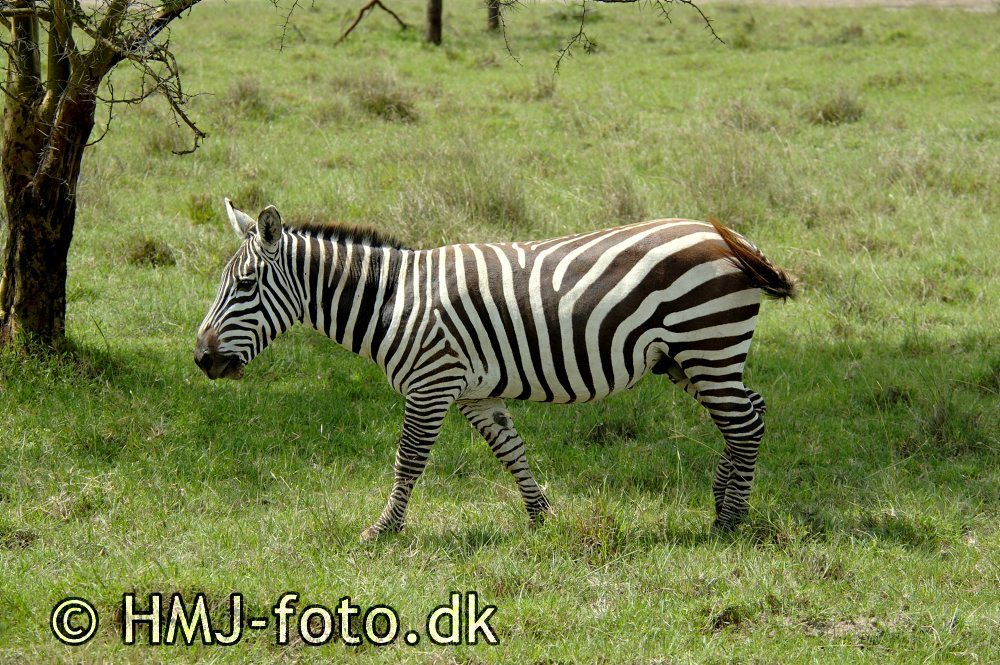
291, 234, 401, 358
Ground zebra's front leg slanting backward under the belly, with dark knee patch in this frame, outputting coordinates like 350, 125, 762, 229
458, 399, 552, 527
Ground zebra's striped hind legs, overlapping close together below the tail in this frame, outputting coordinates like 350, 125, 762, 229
693, 376, 766, 531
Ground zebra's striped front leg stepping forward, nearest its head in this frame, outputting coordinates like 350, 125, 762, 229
361, 394, 453, 541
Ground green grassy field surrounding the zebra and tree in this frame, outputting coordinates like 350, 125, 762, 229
0, 0, 1000, 663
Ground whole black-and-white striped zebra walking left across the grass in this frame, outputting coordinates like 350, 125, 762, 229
195, 199, 793, 540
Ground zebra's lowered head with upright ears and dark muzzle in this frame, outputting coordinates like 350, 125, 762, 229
194, 199, 302, 379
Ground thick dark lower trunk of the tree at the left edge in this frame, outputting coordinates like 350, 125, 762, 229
0, 83, 96, 348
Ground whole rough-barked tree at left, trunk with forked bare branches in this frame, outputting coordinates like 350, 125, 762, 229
0, 0, 204, 349
